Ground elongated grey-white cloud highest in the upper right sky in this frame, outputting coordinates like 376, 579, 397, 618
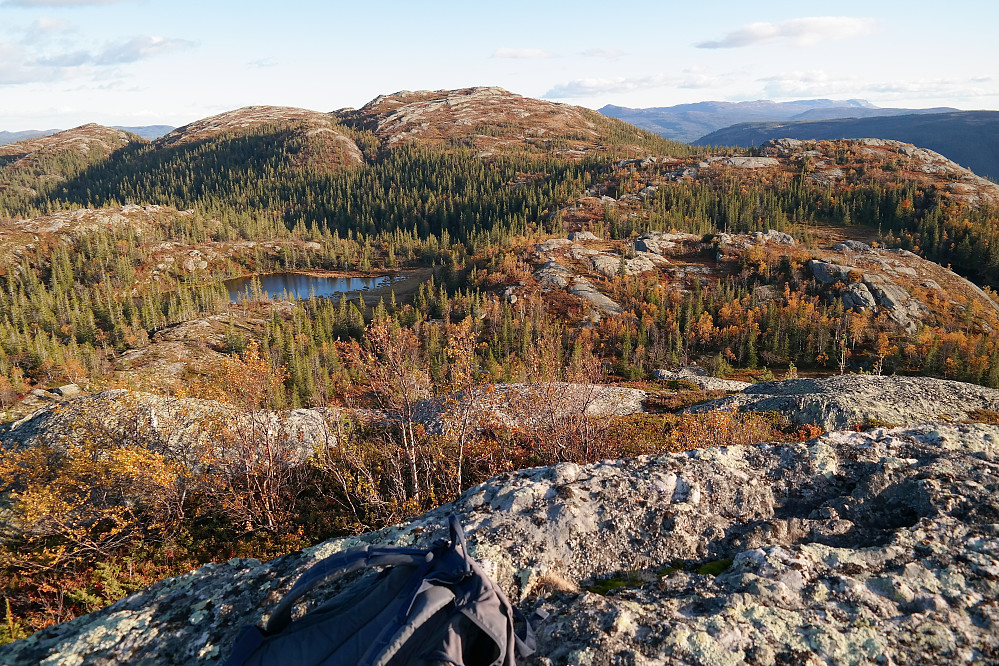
695, 16, 874, 49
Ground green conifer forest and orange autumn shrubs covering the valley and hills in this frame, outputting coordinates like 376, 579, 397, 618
0, 101, 999, 641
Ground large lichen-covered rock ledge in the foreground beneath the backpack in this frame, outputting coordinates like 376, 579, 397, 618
0, 424, 999, 666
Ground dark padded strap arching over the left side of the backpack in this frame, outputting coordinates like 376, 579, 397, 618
264, 546, 434, 635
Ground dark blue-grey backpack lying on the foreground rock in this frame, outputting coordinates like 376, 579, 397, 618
226, 515, 534, 666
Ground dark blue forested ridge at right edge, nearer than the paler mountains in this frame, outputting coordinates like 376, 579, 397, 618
694, 111, 999, 180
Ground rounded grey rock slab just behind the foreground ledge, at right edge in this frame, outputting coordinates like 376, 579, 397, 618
690, 375, 999, 430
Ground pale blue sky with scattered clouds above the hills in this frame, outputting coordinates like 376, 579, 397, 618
0, 0, 999, 131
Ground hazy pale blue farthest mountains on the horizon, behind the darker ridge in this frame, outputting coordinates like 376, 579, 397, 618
599, 99, 957, 143
